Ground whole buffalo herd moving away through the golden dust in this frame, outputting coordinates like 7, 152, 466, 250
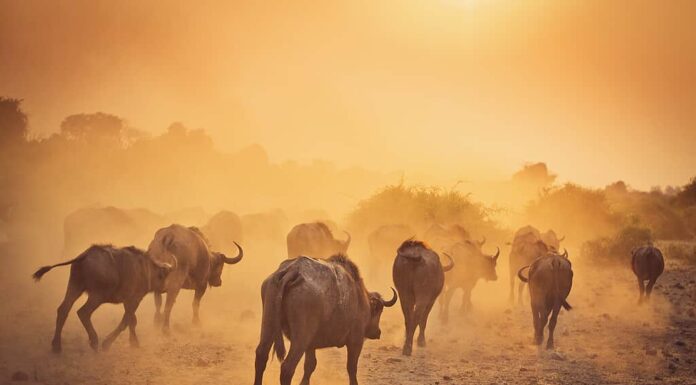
33, 207, 664, 385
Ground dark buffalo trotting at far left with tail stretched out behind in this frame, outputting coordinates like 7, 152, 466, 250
33, 245, 172, 353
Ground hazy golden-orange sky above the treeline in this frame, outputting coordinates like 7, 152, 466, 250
0, 0, 696, 188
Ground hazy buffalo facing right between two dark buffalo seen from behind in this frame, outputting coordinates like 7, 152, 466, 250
438, 241, 500, 323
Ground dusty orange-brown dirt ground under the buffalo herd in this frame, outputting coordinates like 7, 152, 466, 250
0, 243, 696, 385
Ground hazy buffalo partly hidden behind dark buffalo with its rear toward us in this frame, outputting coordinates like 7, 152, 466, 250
509, 226, 565, 304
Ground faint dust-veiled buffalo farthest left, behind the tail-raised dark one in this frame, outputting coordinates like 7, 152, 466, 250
63, 207, 171, 256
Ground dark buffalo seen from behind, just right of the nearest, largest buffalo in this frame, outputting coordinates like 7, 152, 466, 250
392, 239, 454, 356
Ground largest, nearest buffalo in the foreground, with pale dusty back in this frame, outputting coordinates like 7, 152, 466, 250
254, 255, 397, 385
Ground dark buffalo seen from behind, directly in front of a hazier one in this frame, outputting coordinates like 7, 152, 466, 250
517, 252, 573, 349
